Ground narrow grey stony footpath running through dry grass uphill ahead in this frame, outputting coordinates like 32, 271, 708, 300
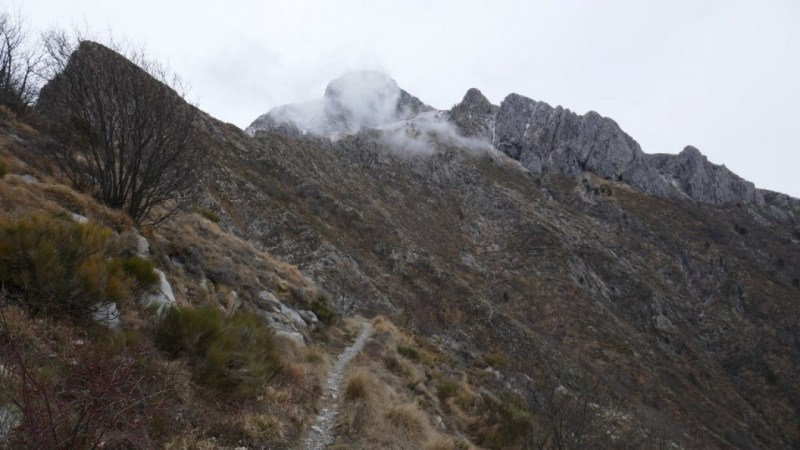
305, 322, 372, 450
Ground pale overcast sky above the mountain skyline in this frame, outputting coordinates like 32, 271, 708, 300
17, 0, 800, 197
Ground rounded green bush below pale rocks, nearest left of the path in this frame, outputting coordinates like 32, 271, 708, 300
156, 307, 281, 395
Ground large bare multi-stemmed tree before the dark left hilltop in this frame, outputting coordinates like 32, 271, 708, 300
37, 32, 207, 224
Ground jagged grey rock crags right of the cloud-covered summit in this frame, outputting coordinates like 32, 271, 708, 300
488, 94, 763, 209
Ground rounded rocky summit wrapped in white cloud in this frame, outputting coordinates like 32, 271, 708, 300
247, 71, 433, 137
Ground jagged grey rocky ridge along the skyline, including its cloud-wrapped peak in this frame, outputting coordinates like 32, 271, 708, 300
247, 72, 800, 213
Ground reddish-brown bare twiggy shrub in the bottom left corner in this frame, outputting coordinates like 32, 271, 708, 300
0, 306, 167, 450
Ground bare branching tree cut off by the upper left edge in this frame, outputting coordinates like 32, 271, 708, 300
0, 7, 42, 112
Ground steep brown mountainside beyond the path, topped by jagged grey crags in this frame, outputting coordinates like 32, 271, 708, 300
207, 74, 800, 448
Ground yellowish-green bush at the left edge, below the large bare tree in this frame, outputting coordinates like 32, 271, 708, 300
0, 216, 158, 320
